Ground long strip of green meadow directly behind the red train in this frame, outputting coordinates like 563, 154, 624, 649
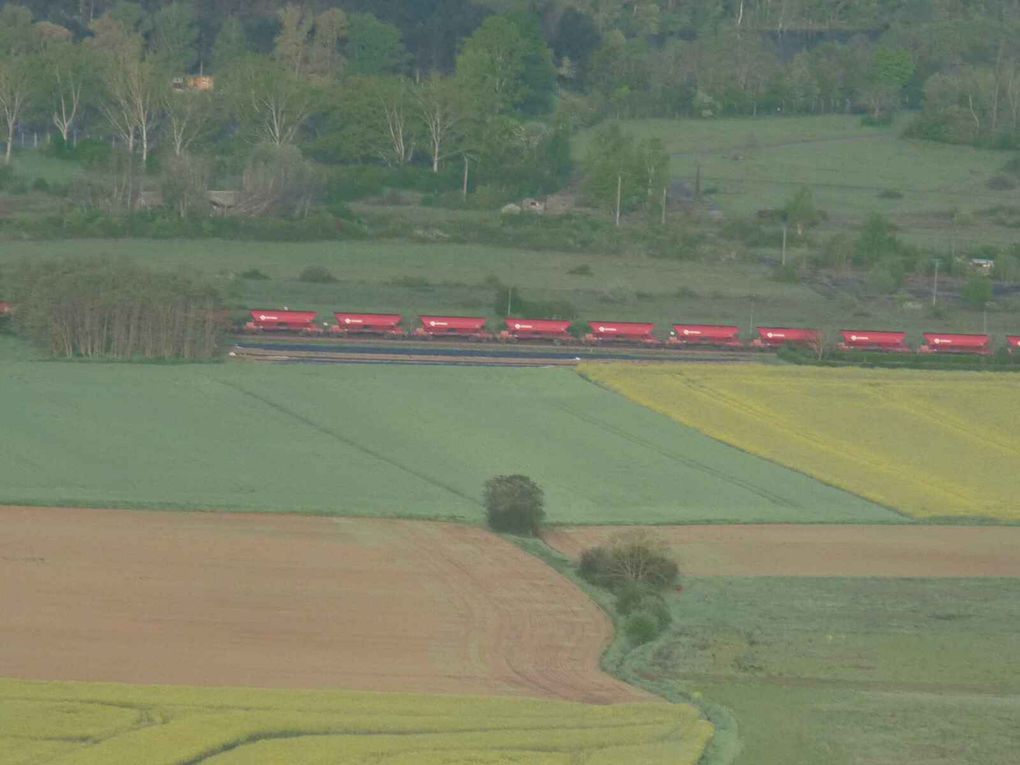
0, 240, 1017, 339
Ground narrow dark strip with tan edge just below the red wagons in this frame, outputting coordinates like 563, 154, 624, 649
231, 336, 758, 366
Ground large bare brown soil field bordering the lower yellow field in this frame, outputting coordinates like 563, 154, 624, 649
0, 507, 649, 703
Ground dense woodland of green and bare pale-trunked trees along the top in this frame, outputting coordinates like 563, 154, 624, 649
0, 0, 1020, 224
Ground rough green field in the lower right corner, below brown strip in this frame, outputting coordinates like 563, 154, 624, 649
624, 577, 1020, 765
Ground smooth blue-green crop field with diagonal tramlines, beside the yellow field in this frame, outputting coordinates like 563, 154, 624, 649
0, 346, 901, 523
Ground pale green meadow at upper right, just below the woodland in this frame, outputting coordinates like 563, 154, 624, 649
577, 114, 1017, 249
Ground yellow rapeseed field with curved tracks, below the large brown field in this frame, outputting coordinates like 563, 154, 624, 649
0, 679, 713, 765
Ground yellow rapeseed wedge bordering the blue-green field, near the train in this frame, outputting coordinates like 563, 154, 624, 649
581, 364, 1020, 520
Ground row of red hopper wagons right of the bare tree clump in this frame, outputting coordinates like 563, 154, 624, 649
244, 310, 1020, 356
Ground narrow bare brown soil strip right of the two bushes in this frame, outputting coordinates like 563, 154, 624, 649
545, 524, 1020, 577
